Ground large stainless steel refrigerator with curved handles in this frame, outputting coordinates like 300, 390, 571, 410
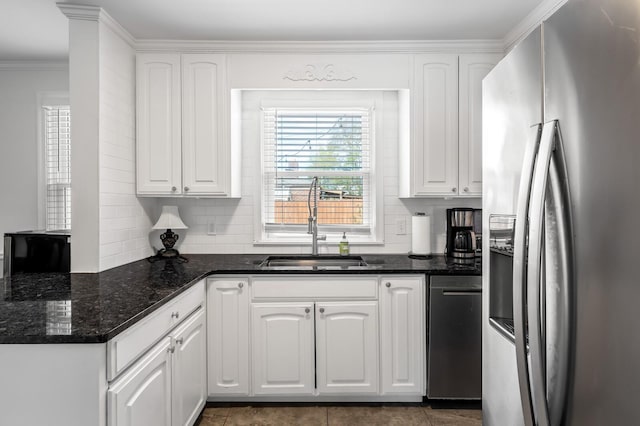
482, 0, 640, 426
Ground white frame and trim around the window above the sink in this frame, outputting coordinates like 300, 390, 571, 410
254, 94, 384, 245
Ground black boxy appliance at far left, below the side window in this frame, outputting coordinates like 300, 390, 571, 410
3, 231, 71, 277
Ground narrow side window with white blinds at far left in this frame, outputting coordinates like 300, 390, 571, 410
43, 105, 71, 231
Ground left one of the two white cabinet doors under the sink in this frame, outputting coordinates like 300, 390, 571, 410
251, 303, 314, 395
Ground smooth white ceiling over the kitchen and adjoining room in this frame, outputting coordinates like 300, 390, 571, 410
0, 0, 544, 61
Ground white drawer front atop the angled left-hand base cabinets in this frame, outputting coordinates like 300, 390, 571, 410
107, 281, 204, 381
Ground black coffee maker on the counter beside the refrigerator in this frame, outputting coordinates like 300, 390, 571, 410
446, 207, 482, 262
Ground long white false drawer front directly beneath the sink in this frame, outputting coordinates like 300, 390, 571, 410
251, 275, 378, 300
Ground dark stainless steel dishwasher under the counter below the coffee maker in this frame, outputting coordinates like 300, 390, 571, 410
427, 276, 482, 399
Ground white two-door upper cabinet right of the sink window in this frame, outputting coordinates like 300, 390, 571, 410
400, 54, 500, 197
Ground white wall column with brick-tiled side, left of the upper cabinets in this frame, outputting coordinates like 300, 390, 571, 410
59, 3, 156, 272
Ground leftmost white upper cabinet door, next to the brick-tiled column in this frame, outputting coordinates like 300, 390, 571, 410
136, 54, 182, 195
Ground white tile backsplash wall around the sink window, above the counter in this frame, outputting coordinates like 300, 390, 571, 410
170, 91, 481, 253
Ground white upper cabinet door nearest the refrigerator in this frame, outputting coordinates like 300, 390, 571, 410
459, 54, 501, 197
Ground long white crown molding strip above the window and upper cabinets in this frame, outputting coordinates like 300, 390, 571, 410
136, 40, 504, 54
